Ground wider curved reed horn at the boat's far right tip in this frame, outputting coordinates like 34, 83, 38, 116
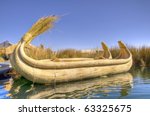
117, 41, 132, 58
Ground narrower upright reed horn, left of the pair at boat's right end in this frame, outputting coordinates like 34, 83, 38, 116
101, 42, 112, 59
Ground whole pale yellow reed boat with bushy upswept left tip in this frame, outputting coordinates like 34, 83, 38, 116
10, 16, 132, 84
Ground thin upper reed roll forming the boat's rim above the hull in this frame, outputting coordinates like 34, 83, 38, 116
18, 42, 132, 69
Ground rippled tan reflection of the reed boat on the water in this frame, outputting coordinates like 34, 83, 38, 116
10, 73, 133, 99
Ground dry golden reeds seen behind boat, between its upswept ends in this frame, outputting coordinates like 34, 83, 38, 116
25, 45, 102, 60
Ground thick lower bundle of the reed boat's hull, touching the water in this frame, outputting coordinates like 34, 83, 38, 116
11, 48, 132, 84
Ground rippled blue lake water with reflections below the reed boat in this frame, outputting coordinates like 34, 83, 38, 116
0, 68, 150, 99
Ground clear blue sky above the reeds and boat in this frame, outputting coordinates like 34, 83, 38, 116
0, 0, 150, 50
